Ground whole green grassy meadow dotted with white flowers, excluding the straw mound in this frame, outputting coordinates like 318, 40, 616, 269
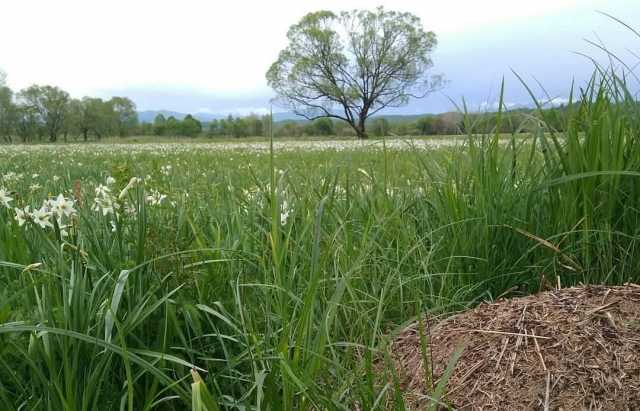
0, 68, 640, 411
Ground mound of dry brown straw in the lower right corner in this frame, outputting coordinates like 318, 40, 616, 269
392, 286, 640, 411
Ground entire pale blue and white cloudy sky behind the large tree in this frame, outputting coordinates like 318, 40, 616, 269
0, 0, 640, 115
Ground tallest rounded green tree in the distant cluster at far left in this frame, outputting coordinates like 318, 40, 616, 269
19, 85, 71, 142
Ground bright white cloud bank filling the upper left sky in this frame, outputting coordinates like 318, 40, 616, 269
0, 0, 600, 96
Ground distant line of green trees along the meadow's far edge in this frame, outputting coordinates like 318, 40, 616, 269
0, 70, 581, 142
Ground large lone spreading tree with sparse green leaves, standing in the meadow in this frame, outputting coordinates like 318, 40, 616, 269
266, 7, 444, 137
